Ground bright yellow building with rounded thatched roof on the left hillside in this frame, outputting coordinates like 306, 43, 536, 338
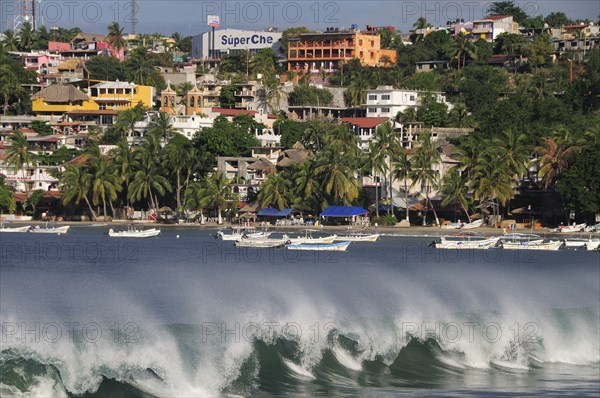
31, 82, 154, 115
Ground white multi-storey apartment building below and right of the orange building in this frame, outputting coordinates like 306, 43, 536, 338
364, 86, 452, 119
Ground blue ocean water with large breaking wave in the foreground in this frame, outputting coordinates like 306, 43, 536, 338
0, 227, 600, 397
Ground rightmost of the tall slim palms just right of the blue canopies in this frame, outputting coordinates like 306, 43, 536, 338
410, 133, 442, 226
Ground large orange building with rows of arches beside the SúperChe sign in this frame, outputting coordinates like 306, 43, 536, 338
288, 31, 397, 73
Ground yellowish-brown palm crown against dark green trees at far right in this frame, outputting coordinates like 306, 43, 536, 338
535, 137, 581, 189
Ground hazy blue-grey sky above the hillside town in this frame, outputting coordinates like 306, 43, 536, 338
0, 0, 600, 36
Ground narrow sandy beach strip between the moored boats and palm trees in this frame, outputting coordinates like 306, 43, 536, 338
10, 220, 600, 237
